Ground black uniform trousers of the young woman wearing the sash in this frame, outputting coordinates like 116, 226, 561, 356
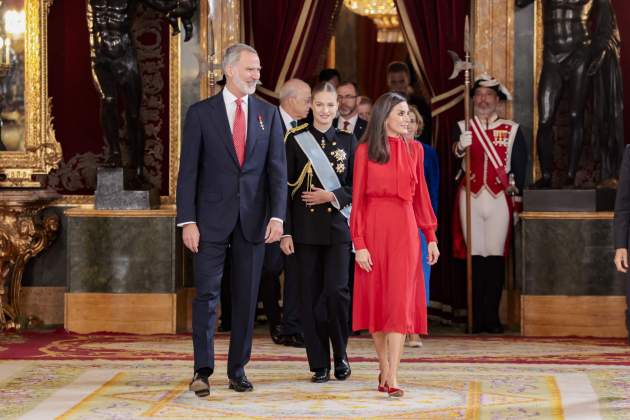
295, 243, 350, 371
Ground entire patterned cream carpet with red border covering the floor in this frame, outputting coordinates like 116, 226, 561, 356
0, 332, 630, 419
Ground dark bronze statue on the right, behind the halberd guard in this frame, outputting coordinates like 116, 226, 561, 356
516, 0, 623, 188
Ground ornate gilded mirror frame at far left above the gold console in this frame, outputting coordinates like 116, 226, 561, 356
0, 0, 62, 187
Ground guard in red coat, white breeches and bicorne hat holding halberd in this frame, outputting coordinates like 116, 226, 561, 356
453, 74, 528, 334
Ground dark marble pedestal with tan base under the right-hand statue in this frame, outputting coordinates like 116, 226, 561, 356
517, 212, 627, 337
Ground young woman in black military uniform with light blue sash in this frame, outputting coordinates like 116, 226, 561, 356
280, 83, 357, 382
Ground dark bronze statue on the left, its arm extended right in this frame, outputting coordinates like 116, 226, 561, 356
88, 0, 197, 189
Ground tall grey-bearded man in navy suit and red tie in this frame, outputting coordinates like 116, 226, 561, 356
177, 44, 287, 396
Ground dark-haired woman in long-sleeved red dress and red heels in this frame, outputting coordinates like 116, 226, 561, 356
350, 92, 439, 397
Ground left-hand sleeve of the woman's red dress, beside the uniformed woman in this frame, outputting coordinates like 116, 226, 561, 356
350, 143, 368, 250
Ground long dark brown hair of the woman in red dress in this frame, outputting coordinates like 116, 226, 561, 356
361, 92, 407, 163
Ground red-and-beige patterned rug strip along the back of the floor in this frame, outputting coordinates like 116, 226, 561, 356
0, 330, 630, 365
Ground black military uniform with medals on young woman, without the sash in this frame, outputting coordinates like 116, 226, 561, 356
284, 124, 357, 382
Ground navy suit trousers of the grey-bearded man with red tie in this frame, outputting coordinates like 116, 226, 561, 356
193, 221, 265, 379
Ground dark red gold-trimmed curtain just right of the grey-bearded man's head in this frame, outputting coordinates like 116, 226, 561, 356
244, 0, 341, 102
